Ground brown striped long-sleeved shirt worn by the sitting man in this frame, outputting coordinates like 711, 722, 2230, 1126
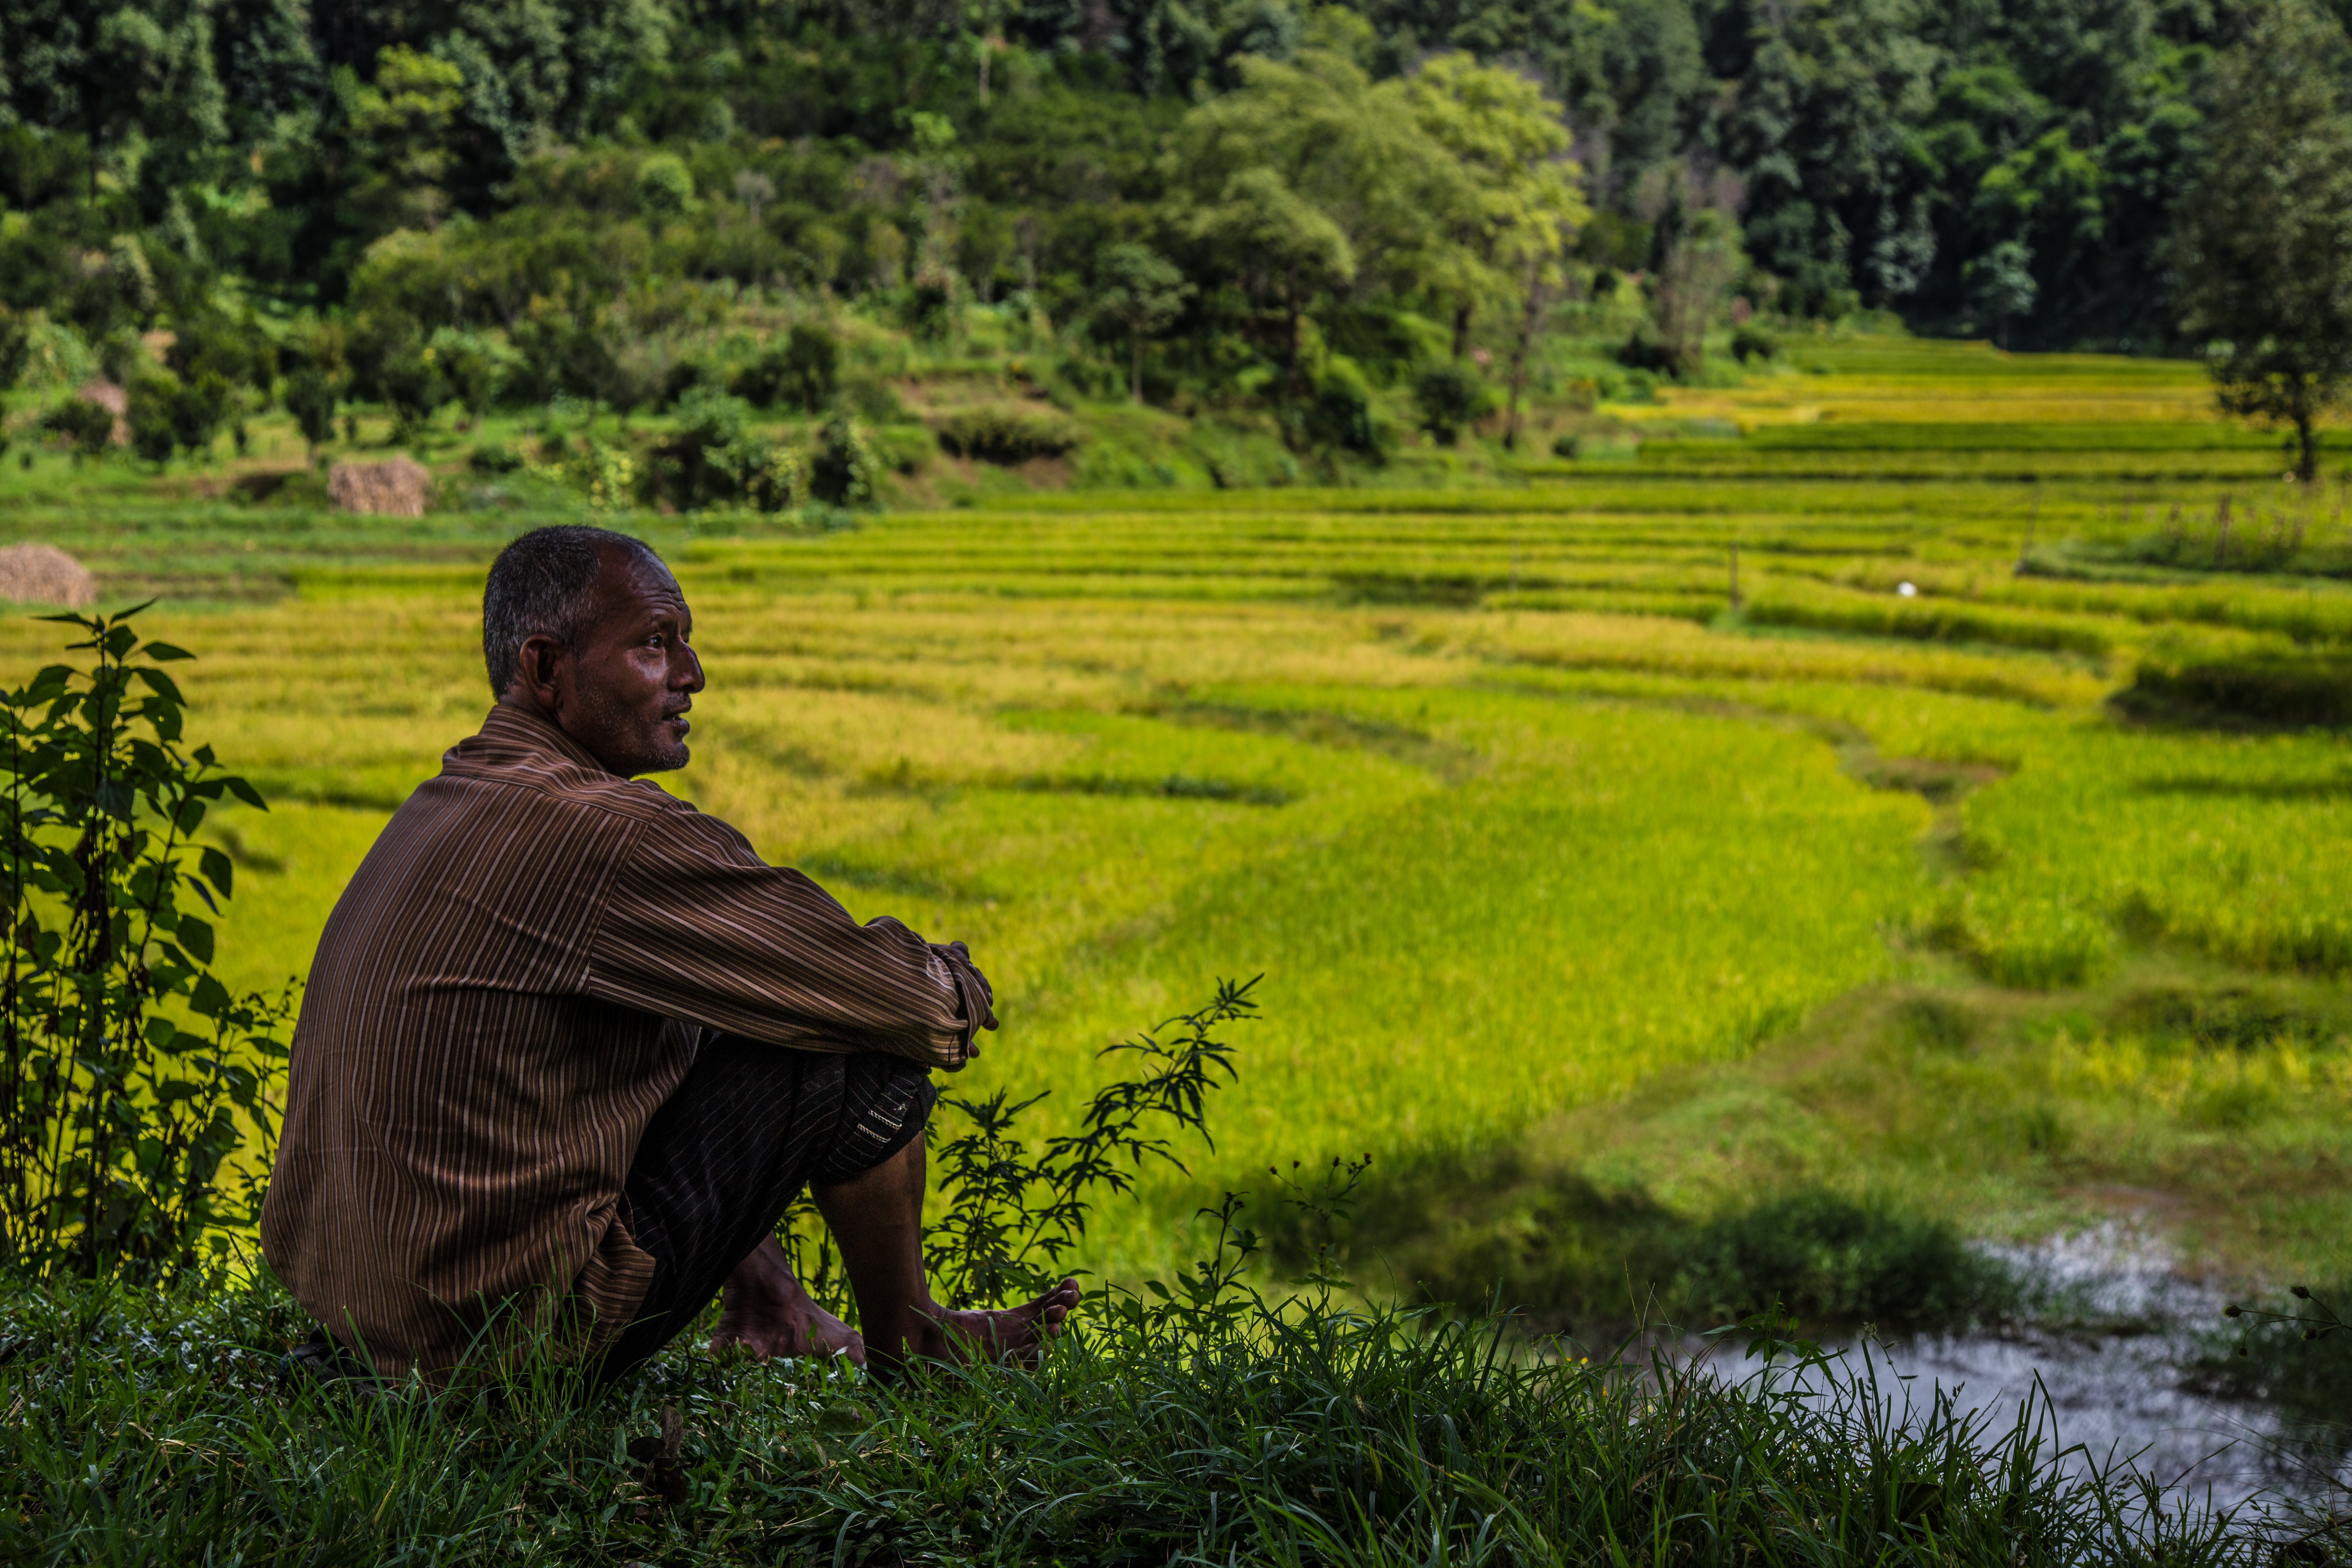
261, 705, 995, 1373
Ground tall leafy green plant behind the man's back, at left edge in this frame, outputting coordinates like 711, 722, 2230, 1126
0, 604, 289, 1279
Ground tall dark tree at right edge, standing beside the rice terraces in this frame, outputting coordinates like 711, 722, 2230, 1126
2178, 0, 2352, 484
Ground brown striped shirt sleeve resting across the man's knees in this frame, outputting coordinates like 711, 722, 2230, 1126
581, 811, 997, 1070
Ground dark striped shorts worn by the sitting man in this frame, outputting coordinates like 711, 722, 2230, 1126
602, 1034, 938, 1380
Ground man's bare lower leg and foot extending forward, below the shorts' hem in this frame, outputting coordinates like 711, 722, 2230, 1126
816, 1138, 1080, 1371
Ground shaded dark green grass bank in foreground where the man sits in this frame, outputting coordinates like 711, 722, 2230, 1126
0, 1260, 2276, 1568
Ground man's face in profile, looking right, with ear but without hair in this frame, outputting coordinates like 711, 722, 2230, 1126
539, 550, 703, 778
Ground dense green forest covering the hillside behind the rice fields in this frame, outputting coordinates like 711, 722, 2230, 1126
0, 0, 2340, 472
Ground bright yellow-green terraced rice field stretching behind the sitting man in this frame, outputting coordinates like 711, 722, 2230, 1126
0, 339, 2352, 1319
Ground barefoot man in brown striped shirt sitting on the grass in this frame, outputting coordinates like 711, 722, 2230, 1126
261, 527, 1077, 1378
